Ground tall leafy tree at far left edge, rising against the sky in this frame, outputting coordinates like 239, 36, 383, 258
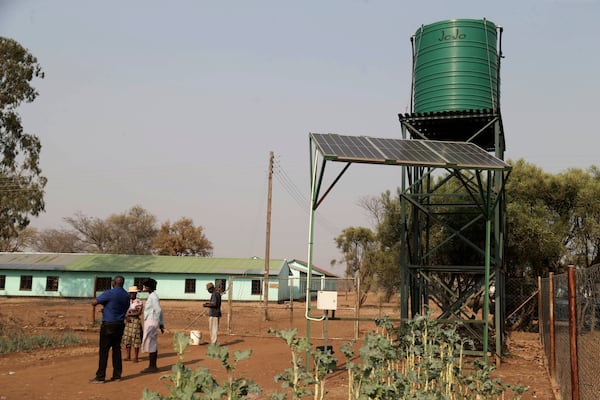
0, 37, 47, 239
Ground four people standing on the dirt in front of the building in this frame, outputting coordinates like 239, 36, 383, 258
90, 275, 221, 383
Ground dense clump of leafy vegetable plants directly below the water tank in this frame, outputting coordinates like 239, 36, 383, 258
341, 314, 527, 400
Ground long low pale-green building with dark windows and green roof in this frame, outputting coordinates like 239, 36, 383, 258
0, 253, 337, 302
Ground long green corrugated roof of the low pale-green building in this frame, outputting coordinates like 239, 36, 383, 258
0, 253, 285, 275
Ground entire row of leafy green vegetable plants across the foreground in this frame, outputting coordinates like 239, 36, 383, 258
142, 314, 528, 400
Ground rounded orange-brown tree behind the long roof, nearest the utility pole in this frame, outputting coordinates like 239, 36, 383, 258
152, 218, 213, 257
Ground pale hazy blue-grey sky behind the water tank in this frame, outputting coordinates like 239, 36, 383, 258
0, 0, 600, 272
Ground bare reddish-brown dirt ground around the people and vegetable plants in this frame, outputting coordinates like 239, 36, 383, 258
0, 297, 555, 400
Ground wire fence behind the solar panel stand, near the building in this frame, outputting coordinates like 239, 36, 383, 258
221, 277, 399, 340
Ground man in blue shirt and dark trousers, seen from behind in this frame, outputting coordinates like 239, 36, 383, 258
90, 275, 129, 383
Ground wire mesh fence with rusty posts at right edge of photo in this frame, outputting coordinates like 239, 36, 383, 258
539, 265, 600, 400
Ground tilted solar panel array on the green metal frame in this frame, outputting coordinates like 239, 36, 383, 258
310, 133, 509, 169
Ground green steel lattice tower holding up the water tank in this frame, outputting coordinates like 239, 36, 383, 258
399, 110, 508, 358
